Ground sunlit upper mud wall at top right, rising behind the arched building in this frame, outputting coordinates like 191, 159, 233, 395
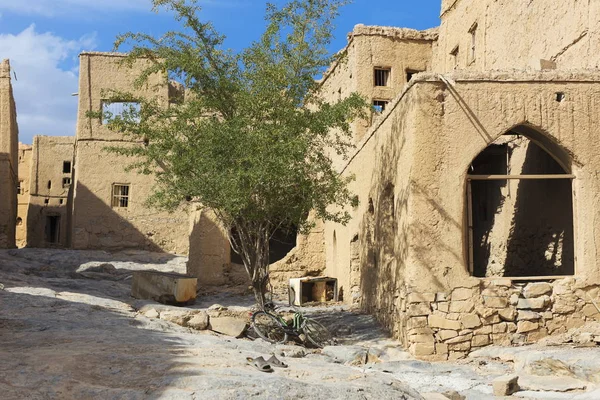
434, 0, 600, 72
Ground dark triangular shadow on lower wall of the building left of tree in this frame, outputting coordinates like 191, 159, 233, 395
72, 183, 171, 253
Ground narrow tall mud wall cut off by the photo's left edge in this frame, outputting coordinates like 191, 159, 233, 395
0, 60, 19, 249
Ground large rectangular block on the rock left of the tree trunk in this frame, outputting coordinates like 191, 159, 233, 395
131, 271, 198, 304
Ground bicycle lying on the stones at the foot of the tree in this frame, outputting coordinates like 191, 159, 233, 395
251, 303, 333, 349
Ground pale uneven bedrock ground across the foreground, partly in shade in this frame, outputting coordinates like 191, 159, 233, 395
0, 249, 600, 400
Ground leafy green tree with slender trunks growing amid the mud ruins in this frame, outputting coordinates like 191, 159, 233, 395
104, 0, 368, 306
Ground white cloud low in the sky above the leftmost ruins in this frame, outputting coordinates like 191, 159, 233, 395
0, 25, 95, 143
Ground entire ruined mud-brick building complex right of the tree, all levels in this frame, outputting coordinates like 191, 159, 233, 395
290, 0, 600, 359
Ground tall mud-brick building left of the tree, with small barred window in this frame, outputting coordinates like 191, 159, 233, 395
72, 53, 189, 254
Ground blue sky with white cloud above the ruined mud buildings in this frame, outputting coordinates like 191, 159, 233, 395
0, 0, 441, 143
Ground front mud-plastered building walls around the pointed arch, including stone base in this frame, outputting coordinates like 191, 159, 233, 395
325, 72, 600, 359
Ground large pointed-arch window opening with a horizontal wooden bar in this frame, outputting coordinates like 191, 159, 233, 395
467, 128, 575, 279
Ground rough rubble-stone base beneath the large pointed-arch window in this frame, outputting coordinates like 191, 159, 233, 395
398, 278, 600, 360
